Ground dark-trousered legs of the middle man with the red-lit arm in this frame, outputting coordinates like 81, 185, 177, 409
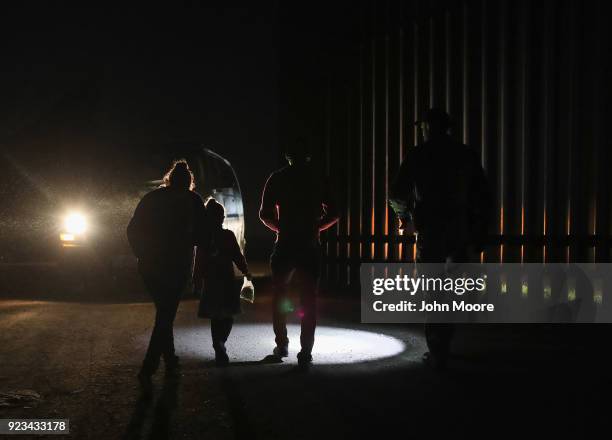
270, 245, 320, 355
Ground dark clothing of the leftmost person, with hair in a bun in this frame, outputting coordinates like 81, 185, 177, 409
127, 186, 208, 374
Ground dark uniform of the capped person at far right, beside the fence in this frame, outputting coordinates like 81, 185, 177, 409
390, 136, 489, 366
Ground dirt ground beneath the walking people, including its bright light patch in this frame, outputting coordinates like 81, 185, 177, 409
0, 274, 612, 440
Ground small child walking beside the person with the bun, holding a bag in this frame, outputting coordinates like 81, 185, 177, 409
193, 199, 252, 366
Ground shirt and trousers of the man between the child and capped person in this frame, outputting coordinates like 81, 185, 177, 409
260, 163, 335, 355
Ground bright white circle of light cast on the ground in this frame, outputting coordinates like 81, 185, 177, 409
167, 323, 405, 364
